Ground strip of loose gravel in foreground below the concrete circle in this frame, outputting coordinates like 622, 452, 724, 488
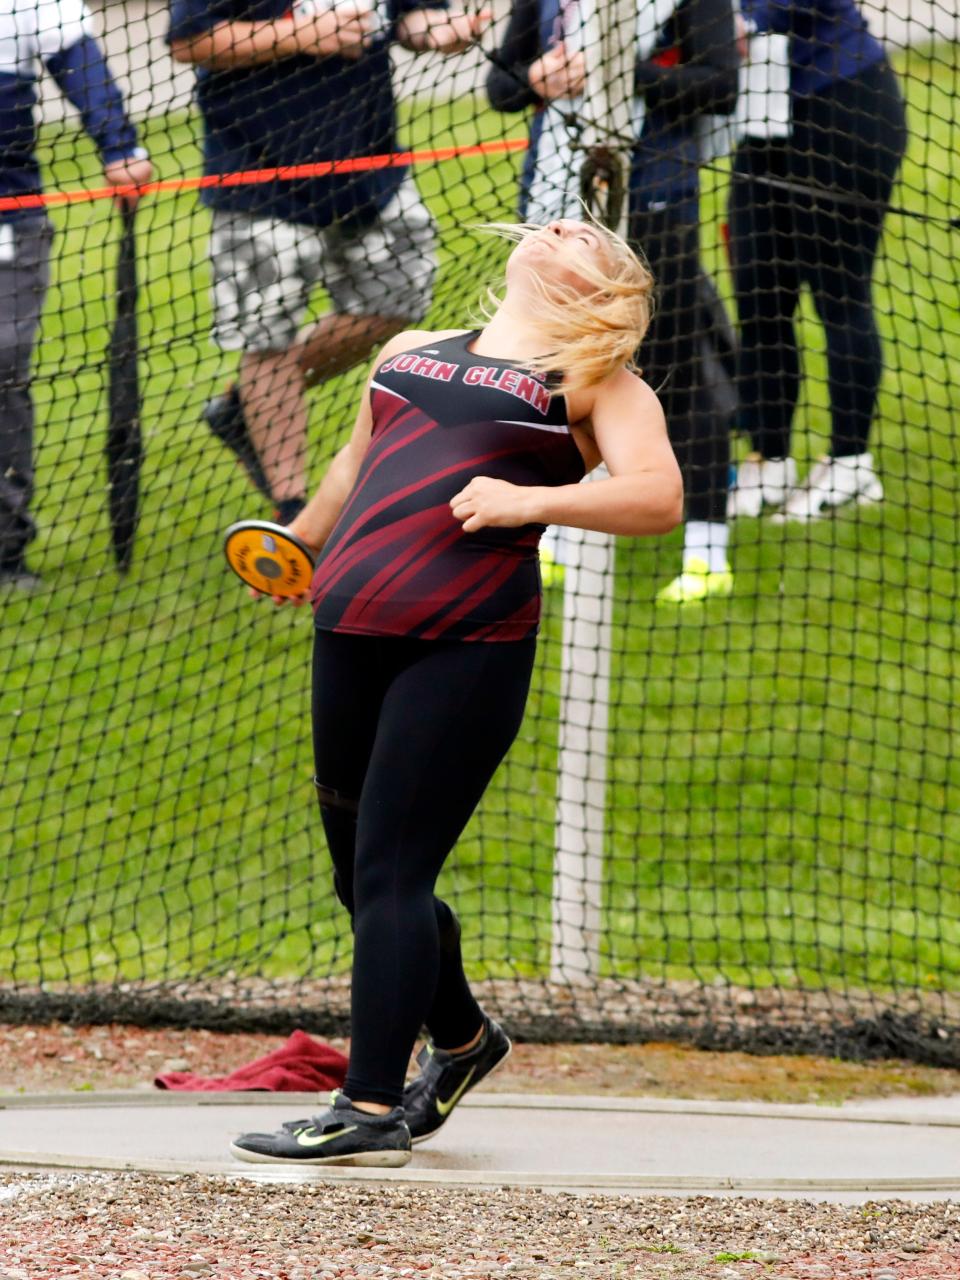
0, 1174, 960, 1280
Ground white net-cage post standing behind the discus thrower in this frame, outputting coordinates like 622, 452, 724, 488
550, 0, 637, 983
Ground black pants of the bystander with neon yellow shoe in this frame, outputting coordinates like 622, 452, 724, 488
630, 202, 731, 521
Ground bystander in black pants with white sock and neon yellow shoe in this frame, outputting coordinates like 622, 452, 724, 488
628, 0, 740, 605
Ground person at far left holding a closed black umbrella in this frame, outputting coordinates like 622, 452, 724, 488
0, 0, 152, 591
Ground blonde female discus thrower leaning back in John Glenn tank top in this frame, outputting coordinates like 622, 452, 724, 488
232, 219, 682, 1165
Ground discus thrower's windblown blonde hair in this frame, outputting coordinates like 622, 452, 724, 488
480, 214, 654, 392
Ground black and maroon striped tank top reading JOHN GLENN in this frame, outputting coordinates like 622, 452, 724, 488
311, 332, 585, 640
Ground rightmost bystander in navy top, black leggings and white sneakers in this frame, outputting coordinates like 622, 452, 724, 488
728, 0, 908, 521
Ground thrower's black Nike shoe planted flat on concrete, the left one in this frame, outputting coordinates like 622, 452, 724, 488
230, 1092, 410, 1169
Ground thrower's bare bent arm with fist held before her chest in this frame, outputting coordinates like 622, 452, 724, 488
451, 370, 684, 538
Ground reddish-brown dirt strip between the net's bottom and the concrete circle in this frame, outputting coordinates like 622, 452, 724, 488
0, 1023, 960, 1111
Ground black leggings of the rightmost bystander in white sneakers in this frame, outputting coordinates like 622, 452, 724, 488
730, 64, 906, 458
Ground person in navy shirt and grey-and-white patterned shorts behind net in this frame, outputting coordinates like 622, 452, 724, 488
168, 0, 489, 520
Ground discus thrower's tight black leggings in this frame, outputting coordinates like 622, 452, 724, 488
314, 631, 536, 1106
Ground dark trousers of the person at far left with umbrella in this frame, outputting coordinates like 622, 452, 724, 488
0, 216, 54, 570
